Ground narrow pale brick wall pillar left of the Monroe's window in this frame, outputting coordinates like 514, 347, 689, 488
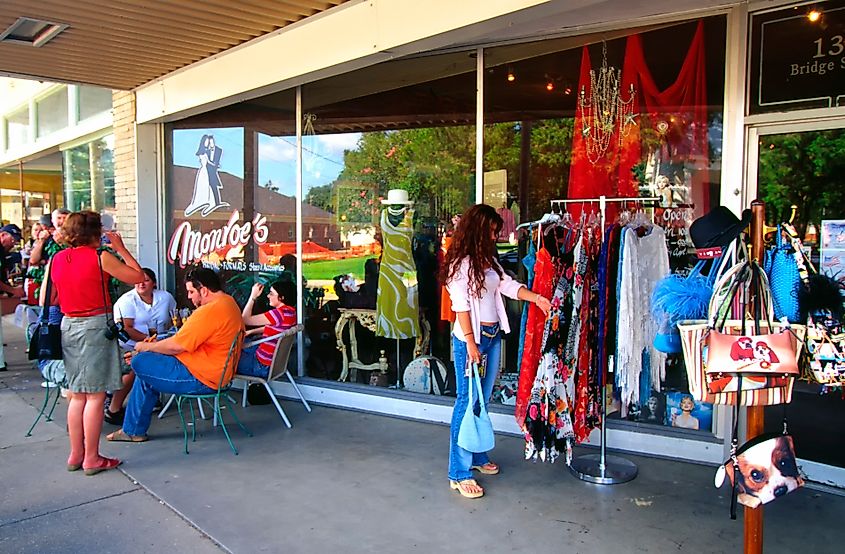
112, 91, 138, 256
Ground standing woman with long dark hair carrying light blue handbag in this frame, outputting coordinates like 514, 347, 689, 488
441, 204, 551, 498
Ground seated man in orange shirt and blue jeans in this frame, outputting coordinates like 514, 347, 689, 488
106, 268, 244, 442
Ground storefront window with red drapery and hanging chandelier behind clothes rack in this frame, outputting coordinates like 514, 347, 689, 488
484, 17, 725, 420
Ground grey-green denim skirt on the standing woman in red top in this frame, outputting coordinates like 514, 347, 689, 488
62, 315, 122, 393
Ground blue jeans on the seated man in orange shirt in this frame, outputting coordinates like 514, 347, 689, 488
123, 352, 215, 437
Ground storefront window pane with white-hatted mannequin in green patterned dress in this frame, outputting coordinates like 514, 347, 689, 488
302, 60, 475, 394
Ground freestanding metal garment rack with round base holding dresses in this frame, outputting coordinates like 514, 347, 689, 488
551, 196, 660, 485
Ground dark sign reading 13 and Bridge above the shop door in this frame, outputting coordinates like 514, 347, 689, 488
749, 2, 845, 114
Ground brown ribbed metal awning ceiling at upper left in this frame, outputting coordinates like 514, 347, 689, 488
0, 0, 348, 90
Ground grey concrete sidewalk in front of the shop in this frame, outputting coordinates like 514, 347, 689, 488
0, 314, 845, 554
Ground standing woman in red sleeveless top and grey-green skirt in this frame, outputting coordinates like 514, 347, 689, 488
48, 211, 144, 475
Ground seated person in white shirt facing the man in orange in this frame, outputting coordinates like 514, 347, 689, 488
105, 267, 176, 425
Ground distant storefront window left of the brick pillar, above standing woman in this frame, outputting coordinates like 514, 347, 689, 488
62, 135, 115, 212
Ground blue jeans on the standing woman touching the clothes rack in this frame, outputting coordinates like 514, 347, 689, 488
449, 325, 502, 481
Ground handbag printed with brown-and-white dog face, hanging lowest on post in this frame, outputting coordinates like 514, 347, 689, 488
714, 422, 804, 519
